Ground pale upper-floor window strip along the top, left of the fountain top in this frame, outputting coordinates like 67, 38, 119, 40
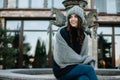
17, 0, 64, 8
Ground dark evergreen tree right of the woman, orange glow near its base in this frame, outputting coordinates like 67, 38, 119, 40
98, 34, 112, 68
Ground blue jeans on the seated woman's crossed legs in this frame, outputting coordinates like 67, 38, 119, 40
59, 64, 98, 80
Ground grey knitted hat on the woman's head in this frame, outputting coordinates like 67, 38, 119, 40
66, 5, 86, 24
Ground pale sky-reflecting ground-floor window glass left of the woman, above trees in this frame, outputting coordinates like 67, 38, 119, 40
6, 20, 58, 55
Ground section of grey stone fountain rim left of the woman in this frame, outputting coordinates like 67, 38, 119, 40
0, 69, 56, 80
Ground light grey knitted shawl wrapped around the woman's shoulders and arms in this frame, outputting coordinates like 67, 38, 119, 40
53, 27, 94, 67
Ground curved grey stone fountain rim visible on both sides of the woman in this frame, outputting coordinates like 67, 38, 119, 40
0, 68, 120, 80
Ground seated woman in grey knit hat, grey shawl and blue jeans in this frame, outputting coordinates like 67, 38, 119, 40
53, 6, 98, 80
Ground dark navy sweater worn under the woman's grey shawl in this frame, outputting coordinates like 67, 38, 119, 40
53, 27, 81, 78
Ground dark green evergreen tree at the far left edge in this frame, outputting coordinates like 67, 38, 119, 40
0, 26, 17, 69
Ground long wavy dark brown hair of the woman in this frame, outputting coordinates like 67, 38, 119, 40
67, 15, 85, 47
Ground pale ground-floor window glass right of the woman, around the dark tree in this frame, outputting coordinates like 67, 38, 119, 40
97, 25, 120, 66
